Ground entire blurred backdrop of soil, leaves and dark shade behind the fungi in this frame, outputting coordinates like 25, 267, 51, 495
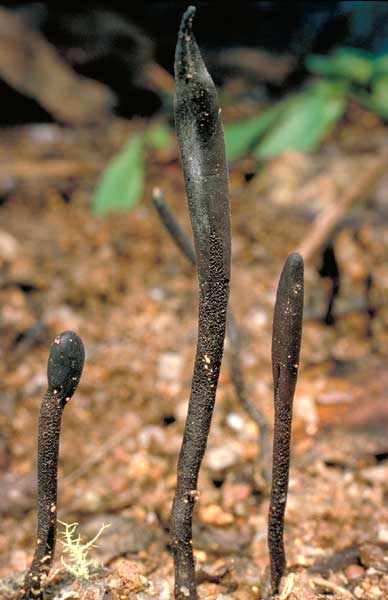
0, 1, 388, 600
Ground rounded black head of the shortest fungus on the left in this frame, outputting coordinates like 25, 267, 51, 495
47, 331, 85, 402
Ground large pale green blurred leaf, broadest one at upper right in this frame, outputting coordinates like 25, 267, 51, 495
255, 81, 347, 159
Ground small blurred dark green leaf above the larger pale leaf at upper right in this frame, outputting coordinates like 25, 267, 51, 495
306, 48, 375, 84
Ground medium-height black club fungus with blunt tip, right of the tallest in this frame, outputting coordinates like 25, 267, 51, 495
268, 253, 304, 594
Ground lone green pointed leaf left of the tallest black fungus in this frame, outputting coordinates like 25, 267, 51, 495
92, 134, 144, 215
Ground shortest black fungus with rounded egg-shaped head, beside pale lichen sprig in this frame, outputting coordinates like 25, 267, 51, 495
19, 331, 85, 599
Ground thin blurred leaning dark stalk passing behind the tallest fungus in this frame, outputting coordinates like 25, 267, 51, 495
152, 188, 271, 491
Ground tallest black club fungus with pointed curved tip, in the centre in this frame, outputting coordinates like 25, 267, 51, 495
170, 7, 230, 600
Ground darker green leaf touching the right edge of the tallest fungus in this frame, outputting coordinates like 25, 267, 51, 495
225, 103, 283, 161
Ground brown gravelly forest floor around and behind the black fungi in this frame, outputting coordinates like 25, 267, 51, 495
0, 108, 388, 600
